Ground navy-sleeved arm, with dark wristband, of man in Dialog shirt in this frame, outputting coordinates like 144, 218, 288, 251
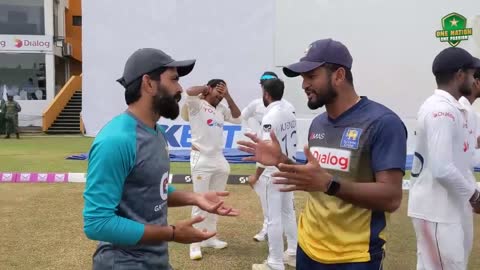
273, 115, 407, 212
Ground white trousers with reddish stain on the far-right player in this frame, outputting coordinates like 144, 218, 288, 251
412, 211, 473, 270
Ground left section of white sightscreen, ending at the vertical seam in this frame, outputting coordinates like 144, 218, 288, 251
82, 0, 275, 139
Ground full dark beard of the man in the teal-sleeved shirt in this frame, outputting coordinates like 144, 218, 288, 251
152, 85, 182, 120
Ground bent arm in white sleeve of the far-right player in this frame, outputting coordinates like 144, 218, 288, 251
424, 107, 476, 201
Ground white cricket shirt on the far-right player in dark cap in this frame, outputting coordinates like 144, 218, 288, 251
408, 90, 476, 223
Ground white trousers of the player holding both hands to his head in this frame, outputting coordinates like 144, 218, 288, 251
190, 150, 230, 232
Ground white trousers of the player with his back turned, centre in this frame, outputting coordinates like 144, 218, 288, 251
261, 175, 298, 270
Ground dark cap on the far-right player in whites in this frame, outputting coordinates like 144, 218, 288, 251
432, 47, 480, 74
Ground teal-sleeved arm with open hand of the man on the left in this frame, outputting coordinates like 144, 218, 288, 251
83, 137, 235, 245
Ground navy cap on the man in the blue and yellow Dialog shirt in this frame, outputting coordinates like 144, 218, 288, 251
283, 38, 353, 77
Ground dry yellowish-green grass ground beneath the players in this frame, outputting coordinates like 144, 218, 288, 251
0, 137, 480, 270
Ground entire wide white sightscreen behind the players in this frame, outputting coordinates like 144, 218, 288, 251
82, 0, 480, 151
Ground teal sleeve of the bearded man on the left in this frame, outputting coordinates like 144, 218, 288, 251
83, 136, 145, 245
